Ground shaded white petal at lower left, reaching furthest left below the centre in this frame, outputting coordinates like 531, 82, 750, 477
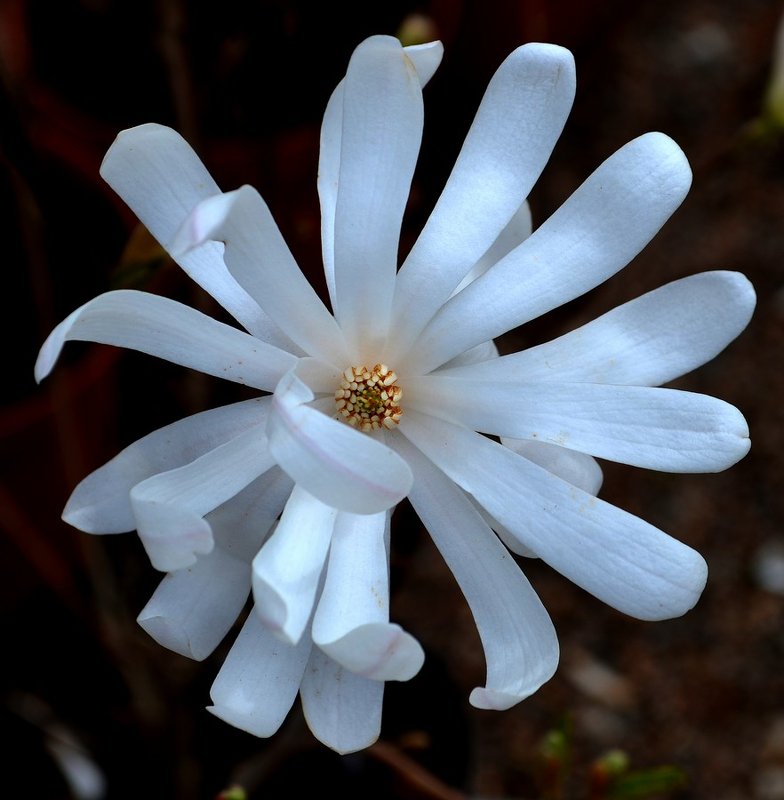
63, 397, 271, 533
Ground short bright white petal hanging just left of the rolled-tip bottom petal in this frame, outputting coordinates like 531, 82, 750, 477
253, 486, 338, 644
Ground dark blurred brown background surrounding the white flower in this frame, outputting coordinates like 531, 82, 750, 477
0, 0, 784, 800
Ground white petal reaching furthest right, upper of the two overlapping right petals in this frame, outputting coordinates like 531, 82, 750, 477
444, 272, 756, 386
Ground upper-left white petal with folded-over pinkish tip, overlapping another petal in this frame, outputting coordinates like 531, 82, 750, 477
172, 186, 349, 367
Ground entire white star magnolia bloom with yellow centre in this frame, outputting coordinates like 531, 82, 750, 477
36, 36, 754, 752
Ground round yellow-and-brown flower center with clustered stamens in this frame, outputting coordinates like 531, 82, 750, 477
335, 364, 403, 432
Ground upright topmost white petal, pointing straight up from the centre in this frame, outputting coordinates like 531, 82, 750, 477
334, 36, 424, 360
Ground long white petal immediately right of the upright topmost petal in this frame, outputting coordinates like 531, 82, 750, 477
386, 44, 575, 363
